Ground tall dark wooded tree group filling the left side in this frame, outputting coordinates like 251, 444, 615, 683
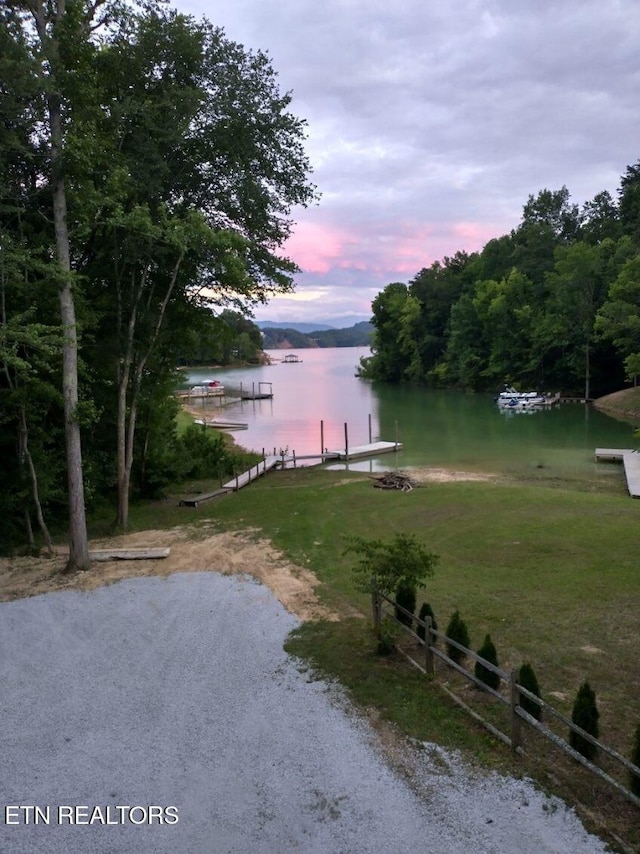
0, 0, 316, 570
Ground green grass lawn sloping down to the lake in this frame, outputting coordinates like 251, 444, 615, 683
124, 469, 640, 850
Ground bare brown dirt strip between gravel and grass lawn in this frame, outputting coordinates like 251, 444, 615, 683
0, 526, 338, 620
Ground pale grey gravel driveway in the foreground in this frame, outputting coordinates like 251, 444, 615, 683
0, 573, 607, 854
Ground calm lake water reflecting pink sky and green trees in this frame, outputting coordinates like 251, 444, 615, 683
187, 348, 634, 478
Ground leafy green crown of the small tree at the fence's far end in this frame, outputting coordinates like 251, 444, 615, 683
344, 534, 438, 607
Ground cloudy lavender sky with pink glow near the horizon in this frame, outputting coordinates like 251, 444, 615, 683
175, 0, 640, 326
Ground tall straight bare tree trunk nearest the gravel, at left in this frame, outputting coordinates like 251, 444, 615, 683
34, 0, 90, 572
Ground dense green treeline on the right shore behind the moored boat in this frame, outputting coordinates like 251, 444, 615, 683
360, 168, 640, 398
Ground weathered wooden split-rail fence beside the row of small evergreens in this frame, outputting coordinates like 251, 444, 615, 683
372, 590, 640, 806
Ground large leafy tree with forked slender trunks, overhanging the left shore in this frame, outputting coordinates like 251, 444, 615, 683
82, 12, 315, 528
